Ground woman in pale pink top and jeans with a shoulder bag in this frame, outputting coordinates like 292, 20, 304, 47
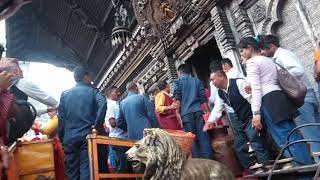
238, 37, 312, 164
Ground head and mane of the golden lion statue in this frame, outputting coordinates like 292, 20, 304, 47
126, 129, 185, 180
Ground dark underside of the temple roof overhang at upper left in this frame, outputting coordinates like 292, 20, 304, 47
6, 0, 137, 79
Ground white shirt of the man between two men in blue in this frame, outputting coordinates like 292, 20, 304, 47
105, 99, 127, 138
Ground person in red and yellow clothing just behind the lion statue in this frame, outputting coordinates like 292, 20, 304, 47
155, 81, 182, 130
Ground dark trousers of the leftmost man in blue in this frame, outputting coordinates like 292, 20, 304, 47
64, 141, 90, 180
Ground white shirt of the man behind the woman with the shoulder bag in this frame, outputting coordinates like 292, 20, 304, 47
273, 47, 312, 89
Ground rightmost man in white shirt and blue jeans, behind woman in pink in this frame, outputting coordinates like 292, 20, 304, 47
259, 35, 320, 158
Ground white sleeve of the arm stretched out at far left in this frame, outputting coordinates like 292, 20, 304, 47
16, 79, 58, 107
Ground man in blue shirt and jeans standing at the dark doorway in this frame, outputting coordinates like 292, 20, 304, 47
173, 64, 213, 159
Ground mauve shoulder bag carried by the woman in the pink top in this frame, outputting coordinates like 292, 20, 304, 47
273, 60, 307, 107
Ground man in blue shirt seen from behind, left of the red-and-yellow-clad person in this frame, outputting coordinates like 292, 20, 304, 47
117, 82, 152, 140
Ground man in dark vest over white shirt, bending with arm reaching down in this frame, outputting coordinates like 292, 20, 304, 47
204, 71, 269, 170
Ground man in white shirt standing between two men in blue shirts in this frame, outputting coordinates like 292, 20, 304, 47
105, 86, 130, 176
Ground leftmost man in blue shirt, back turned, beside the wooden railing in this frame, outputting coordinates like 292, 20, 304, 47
58, 67, 108, 180
